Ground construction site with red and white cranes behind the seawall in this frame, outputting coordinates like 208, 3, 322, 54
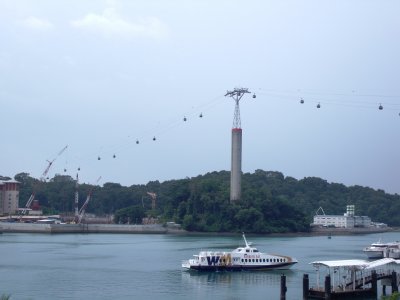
0, 146, 182, 233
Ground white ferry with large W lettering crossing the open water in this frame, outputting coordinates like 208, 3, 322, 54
182, 233, 298, 271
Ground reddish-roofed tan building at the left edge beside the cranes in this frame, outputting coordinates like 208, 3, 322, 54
0, 180, 19, 216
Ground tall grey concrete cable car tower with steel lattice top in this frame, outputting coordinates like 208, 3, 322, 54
225, 88, 250, 202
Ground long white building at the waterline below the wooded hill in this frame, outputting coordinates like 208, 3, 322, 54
311, 205, 372, 228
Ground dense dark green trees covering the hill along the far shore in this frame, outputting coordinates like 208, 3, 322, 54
1, 170, 400, 234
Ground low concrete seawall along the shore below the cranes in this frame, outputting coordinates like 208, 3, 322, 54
0, 223, 170, 234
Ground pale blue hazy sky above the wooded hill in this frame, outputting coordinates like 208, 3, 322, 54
0, 0, 400, 193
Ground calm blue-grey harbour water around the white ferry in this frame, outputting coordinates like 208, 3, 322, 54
0, 232, 400, 300
